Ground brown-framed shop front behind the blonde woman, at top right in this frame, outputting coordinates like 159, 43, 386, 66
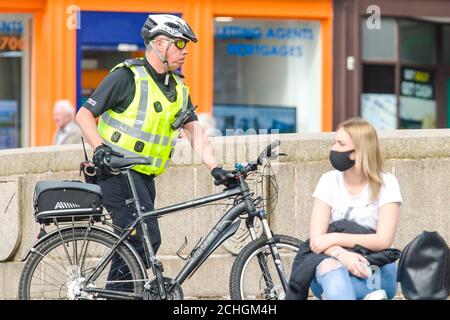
334, 0, 450, 129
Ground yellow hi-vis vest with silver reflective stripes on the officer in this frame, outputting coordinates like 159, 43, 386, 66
98, 59, 189, 175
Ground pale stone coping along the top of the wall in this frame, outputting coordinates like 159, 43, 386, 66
0, 129, 450, 176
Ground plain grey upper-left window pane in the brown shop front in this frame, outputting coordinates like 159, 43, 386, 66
361, 18, 396, 61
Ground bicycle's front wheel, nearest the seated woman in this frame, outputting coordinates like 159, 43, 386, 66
230, 235, 302, 300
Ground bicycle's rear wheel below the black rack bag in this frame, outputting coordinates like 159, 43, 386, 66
19, 228, 145, 300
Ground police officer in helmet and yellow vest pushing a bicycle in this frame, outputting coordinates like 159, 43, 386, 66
76, 14, 233, 290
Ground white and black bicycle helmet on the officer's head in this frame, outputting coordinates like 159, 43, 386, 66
141, 14, 197, 45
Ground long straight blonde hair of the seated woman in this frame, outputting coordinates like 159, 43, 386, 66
336, 117, 383, 201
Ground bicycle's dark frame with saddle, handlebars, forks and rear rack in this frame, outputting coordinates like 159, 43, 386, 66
20, 140, 292, 300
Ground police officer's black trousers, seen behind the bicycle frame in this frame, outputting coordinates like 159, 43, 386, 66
97, 170, 161, 291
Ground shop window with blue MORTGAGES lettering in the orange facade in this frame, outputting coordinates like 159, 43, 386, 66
213, 17, 322, 134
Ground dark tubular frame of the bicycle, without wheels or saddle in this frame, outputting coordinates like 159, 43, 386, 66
85, 169, 260, 299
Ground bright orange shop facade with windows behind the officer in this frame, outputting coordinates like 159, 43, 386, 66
0, 0, 333, 149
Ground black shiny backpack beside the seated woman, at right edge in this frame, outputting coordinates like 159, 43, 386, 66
397, 231, 450, 300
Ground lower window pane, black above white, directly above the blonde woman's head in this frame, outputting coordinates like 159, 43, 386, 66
361, 65, 397, 130
